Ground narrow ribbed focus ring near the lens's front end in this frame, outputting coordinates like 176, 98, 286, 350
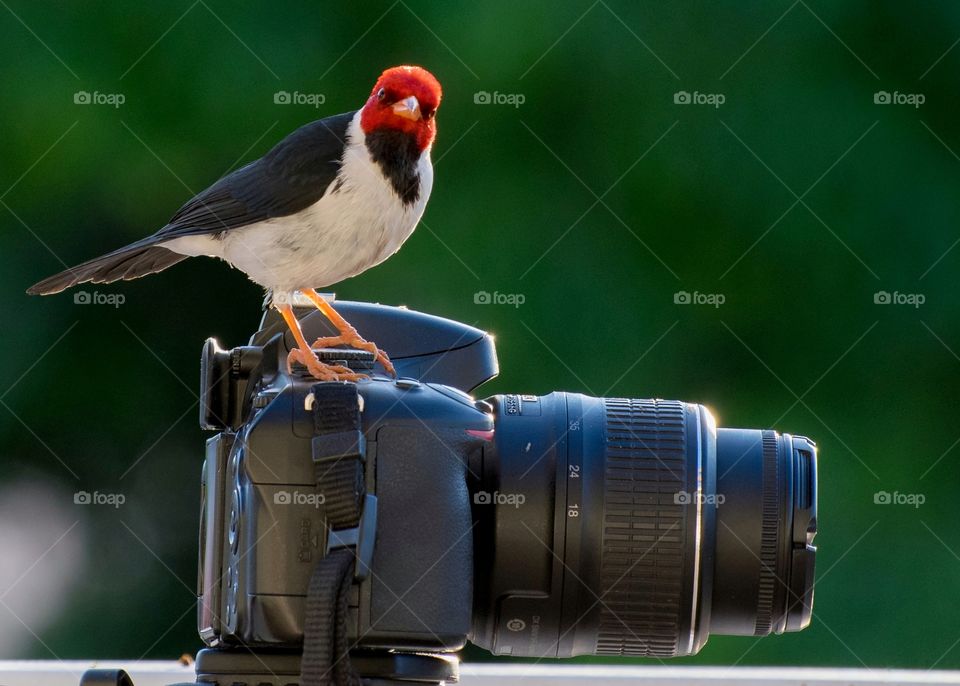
754, 431, 780, 636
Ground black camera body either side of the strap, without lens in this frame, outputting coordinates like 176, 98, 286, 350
200, 362, 493, 651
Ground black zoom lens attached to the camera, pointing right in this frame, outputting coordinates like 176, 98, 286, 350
471, 393, 817, 658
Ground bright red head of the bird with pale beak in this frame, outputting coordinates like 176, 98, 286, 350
360, 66, 443, 152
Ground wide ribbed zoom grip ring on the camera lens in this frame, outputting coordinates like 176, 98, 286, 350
596, 399, 687, 657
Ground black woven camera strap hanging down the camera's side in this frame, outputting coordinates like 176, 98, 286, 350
300, 382, 366, 686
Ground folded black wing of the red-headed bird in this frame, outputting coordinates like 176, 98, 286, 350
154, 112, 355, 244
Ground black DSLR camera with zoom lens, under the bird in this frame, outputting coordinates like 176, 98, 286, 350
86, 302, 817, 686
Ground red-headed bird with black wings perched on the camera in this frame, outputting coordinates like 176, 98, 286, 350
27, 65, 442, 381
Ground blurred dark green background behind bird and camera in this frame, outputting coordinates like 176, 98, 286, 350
0, 0, 960, 668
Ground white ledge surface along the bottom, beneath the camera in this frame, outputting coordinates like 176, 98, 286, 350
0, 660, 960, 686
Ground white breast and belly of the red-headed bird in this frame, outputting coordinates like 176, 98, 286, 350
167, 112, 433, 292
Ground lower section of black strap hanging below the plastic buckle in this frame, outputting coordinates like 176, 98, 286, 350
300, 548, 360, 686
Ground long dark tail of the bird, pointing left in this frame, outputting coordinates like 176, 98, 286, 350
27, 243, 188, 295
